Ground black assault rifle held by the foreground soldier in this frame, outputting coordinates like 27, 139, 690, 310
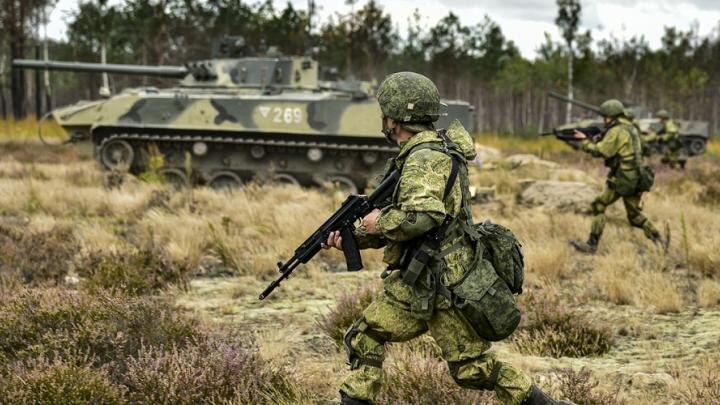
260, 170, 400, 300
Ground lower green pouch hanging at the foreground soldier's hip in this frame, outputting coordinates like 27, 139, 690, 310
449, 259, 520, 341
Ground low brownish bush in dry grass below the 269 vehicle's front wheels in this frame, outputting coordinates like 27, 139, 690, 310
77, 247, 190, 295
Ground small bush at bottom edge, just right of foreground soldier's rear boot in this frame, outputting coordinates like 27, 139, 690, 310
558, 368, 624, 405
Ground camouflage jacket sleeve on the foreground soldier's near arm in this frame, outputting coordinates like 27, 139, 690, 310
378, 149, 452, 242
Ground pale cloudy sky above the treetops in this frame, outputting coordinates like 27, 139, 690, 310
48, 0, 720, 58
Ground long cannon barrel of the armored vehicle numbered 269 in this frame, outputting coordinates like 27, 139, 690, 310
13, 59, 190, 78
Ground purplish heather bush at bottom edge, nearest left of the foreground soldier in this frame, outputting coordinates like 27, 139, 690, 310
123, 332, 297, 404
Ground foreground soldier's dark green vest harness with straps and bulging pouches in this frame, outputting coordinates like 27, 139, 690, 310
384, 131, 524, 341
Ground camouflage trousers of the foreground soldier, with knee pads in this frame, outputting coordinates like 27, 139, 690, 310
340, 293, 532, 404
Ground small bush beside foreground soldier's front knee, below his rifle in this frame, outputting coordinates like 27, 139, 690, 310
317, 287, 377, 346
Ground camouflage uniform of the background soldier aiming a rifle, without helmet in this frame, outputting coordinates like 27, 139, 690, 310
581, 117, 660, 245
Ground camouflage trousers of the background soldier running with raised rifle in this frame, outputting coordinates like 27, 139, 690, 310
590, 188, 660, 240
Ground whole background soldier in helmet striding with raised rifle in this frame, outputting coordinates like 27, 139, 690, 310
570, 100, 669, 253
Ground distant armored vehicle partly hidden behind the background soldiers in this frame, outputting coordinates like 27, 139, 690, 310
548, 91, 710, 157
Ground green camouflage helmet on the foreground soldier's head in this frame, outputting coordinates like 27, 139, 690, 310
377, 72, 440, 124
